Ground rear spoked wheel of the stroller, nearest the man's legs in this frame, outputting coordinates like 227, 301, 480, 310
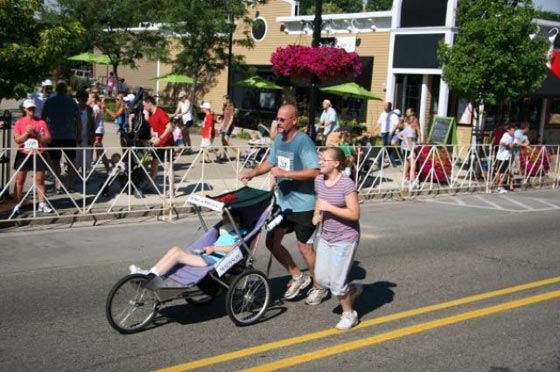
226, 270, 270, 326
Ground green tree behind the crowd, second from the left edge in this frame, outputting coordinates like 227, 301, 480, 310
51, 0, 167, 80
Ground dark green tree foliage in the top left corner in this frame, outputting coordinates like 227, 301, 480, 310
0, 0, 82, 101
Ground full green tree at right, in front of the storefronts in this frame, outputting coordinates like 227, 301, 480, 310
439, 0, 548, 138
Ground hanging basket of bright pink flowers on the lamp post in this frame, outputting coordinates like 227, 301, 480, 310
270, 45, 362, 84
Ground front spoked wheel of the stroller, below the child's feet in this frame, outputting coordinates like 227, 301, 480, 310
105, 274, 159, 334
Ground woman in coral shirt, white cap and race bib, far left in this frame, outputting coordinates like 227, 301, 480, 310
13, 98, 52, 214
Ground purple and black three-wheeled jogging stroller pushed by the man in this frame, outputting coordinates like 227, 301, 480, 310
106, 187, 274, 334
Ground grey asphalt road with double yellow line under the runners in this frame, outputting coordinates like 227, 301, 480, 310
0, 191, 560, 372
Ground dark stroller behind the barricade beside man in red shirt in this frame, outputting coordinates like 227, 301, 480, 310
100, 147, 151, 198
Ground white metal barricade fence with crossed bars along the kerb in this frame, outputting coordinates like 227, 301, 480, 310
0, 145, 560, 221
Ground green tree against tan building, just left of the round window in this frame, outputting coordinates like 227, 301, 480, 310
162, 0, 254, 101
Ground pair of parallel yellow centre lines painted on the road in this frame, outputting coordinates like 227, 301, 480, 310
155, 277, 560, 372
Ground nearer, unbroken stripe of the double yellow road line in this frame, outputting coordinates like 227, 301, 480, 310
244, 291, 560, 372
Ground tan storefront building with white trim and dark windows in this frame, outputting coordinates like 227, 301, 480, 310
97, 0, 560, 144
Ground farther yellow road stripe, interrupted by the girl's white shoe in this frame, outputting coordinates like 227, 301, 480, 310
158, 277, 560, 372
